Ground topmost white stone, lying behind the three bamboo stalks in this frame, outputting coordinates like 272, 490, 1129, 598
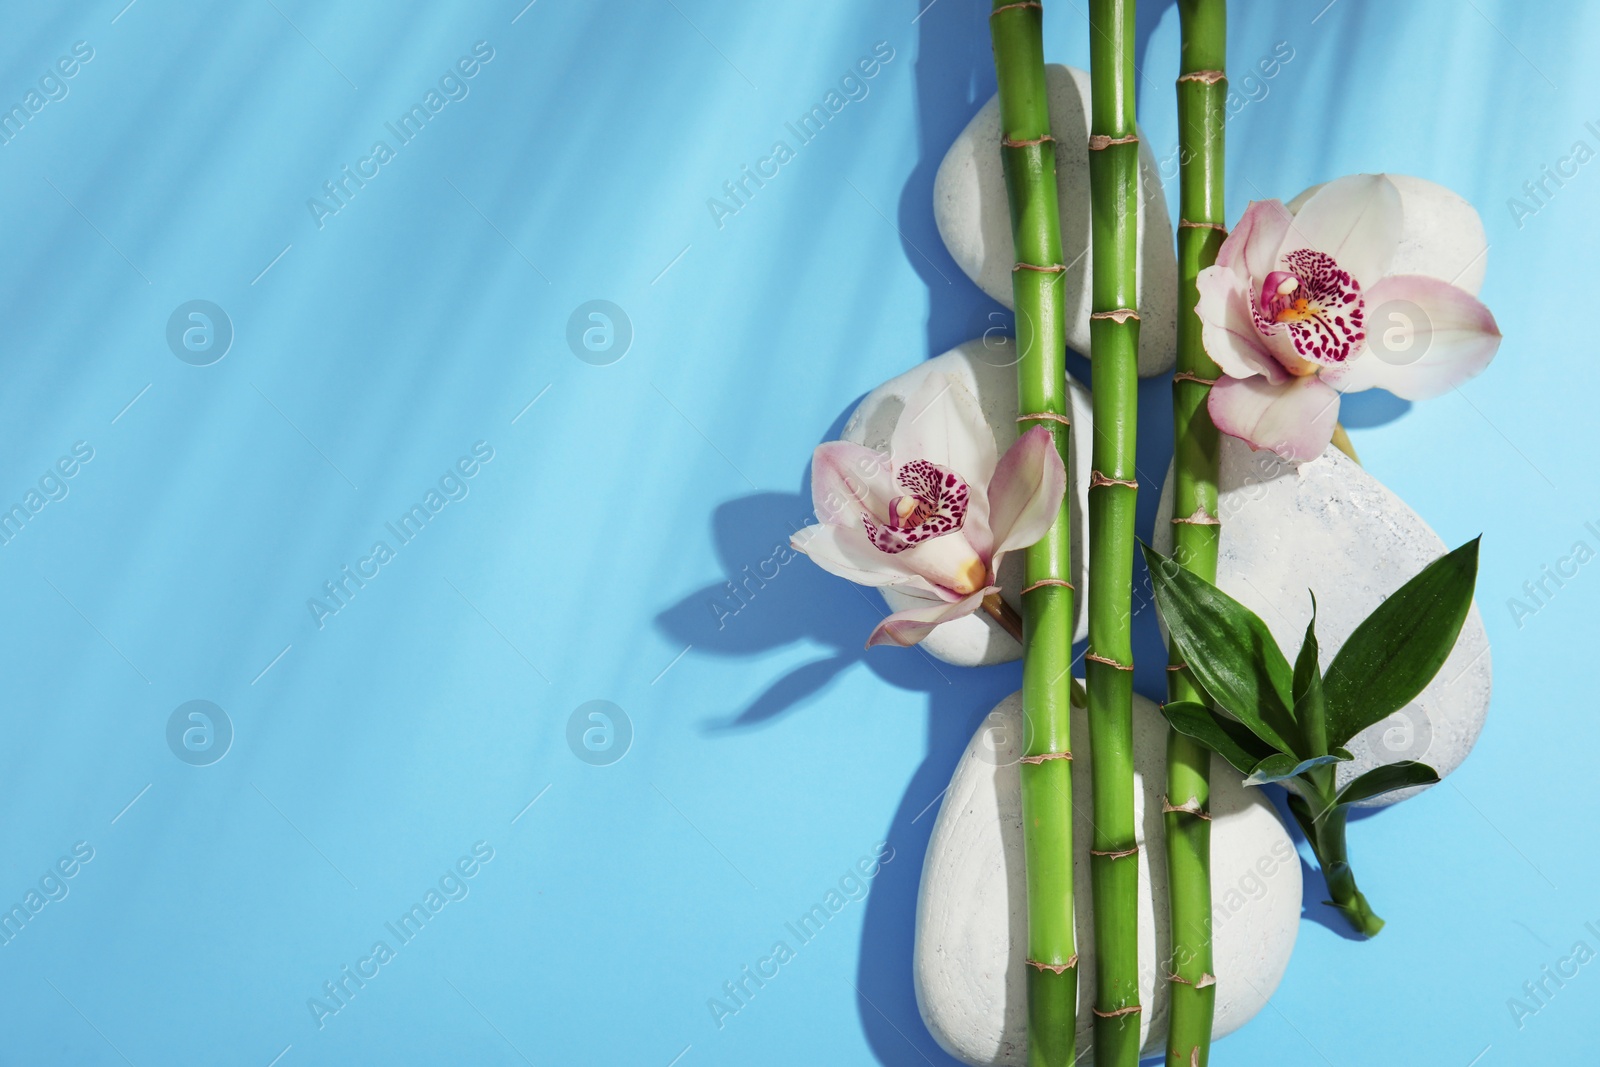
933, 64, 1178, 378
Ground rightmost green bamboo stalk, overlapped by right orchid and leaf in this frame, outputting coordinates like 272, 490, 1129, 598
1165, 0, 1227, 1067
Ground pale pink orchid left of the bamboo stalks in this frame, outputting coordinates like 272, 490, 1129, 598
790, 374, 1067, 648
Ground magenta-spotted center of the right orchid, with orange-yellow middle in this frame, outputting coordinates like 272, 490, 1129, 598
1251, 248, 1366, 367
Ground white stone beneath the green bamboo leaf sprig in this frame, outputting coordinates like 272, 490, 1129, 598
1155, 435, 1493, 808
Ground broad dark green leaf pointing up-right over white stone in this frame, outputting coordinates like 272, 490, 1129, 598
1318, 537, 1480, 745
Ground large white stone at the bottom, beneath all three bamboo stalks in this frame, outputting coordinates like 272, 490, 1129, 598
912, 693, 1301, 1067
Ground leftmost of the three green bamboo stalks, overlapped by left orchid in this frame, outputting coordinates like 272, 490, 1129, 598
989, 0, 1078, 1067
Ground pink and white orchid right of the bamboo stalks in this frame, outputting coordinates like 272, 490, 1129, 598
1197, 174, 1501, 461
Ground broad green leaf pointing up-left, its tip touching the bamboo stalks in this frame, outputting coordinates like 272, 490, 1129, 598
1142, 545, 1304, 755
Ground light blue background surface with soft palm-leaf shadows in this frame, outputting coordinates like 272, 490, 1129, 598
0, 0, 1600, 1067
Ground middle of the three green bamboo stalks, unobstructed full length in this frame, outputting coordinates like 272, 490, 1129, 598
1085, 0, 1141, 1067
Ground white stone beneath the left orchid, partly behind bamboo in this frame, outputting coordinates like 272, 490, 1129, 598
842, 334, 1093, 667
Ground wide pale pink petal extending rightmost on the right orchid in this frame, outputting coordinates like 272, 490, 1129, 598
1325, 274, 1501, 400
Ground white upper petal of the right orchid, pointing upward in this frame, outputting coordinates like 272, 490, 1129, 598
1258, 174, 1405, 290
